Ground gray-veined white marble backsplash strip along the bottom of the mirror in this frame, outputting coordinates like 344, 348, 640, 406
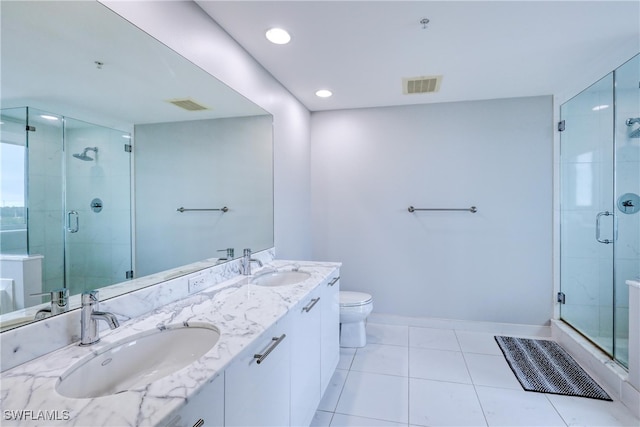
0, 248, 275, 372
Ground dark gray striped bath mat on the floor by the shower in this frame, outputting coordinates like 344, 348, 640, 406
495, 336, 611, 400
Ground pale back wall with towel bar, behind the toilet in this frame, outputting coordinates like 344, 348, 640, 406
311, 96, 553, 325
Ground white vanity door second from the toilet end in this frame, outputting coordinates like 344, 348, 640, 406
290, 289, 324, 426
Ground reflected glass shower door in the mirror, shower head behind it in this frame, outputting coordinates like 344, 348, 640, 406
64, 118, 132, 295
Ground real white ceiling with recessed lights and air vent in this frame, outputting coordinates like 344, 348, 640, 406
197, 0, 640, 111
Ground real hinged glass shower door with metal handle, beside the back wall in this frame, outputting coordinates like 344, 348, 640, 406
560, 73, 615, 355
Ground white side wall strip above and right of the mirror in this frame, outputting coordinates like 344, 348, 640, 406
101, 0, 311, 259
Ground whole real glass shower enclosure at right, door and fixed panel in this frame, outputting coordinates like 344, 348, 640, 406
558, 55, 640, 367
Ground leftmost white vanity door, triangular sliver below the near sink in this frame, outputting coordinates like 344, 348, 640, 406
160, 374, 224, 427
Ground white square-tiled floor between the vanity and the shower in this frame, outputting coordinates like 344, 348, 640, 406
312, 323, 640, 427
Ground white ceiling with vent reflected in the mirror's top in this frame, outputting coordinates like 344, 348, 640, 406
0, 1, 265, 129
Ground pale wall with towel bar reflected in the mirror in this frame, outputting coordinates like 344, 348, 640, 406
135, 115, 273, 277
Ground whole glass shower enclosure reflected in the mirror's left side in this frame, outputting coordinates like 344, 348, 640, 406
0, 107, 132, 309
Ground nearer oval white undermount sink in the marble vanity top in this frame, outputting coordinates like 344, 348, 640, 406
56, 324, 220, 399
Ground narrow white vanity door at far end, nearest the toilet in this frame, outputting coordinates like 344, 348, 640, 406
320, 270, 340, 394
